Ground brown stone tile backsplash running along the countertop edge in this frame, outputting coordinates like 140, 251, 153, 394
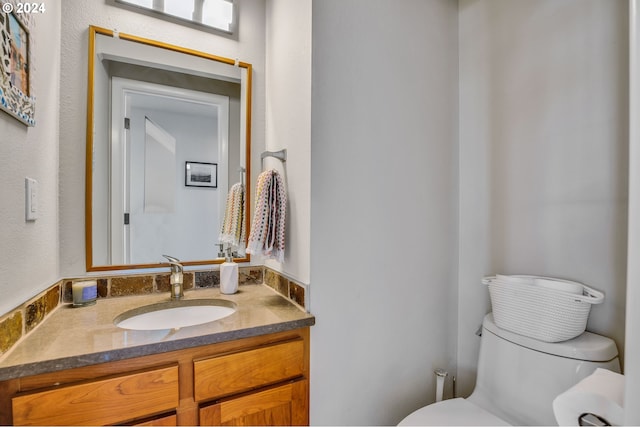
0, 266, 308, 356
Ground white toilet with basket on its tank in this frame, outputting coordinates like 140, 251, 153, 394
399, 313, 620, 426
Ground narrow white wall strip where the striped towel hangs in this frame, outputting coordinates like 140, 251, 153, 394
264, 0, 311, 284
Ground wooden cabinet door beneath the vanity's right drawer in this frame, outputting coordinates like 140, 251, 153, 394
200, 380, 309, 426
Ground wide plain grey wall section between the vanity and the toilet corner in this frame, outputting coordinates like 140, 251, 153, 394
311, 0, 458, 425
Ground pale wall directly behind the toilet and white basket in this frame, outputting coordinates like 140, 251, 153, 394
458, 0, 628, 394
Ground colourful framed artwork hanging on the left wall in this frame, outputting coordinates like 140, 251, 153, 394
0, 7, 35, 126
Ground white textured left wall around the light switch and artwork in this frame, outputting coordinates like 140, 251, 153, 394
0, 2, 60, 316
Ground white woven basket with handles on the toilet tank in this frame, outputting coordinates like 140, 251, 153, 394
482, 275, 604, 342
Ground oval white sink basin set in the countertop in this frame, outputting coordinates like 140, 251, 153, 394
113, 299, 236, 331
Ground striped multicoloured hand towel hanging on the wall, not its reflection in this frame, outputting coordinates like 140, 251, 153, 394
247, 169, 287, 262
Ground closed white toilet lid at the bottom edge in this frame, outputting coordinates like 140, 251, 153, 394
398, 398, 509, 426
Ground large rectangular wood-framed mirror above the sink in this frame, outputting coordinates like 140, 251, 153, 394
86, 27, 251, 271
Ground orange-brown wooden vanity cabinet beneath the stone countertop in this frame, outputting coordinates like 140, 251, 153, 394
0, 328, 309, 426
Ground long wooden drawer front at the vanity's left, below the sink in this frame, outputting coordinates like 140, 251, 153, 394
12, 365, 179, 425
